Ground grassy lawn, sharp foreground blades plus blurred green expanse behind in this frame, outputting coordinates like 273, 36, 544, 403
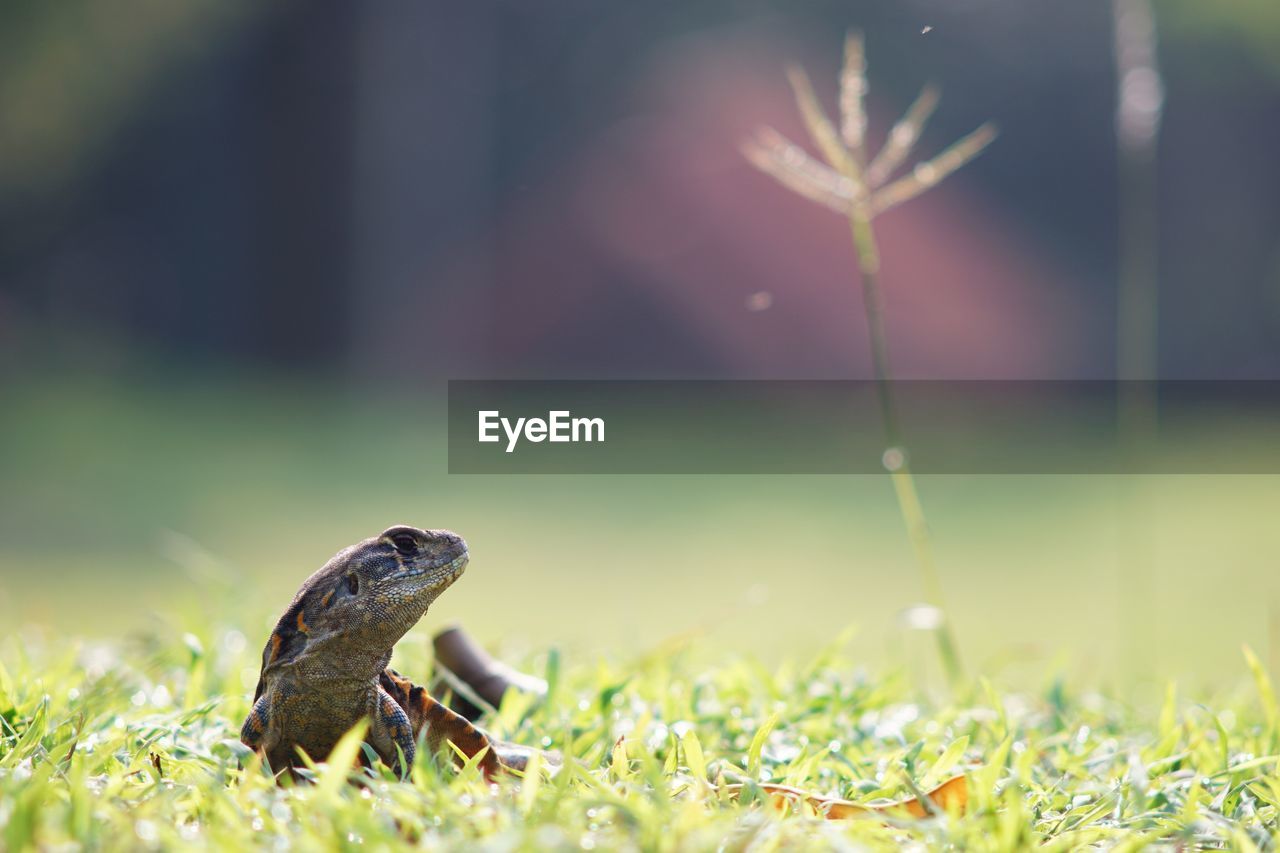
0, 380, 1280, 849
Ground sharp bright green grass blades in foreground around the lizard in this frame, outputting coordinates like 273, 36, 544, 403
0, 622, 1280, 850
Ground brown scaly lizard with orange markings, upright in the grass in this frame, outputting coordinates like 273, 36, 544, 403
241, 525, 529, 777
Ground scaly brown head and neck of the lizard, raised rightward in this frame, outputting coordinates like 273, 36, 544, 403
259, 525, 468, 690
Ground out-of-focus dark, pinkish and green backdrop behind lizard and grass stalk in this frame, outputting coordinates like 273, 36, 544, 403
0, 0, 1280, 679
